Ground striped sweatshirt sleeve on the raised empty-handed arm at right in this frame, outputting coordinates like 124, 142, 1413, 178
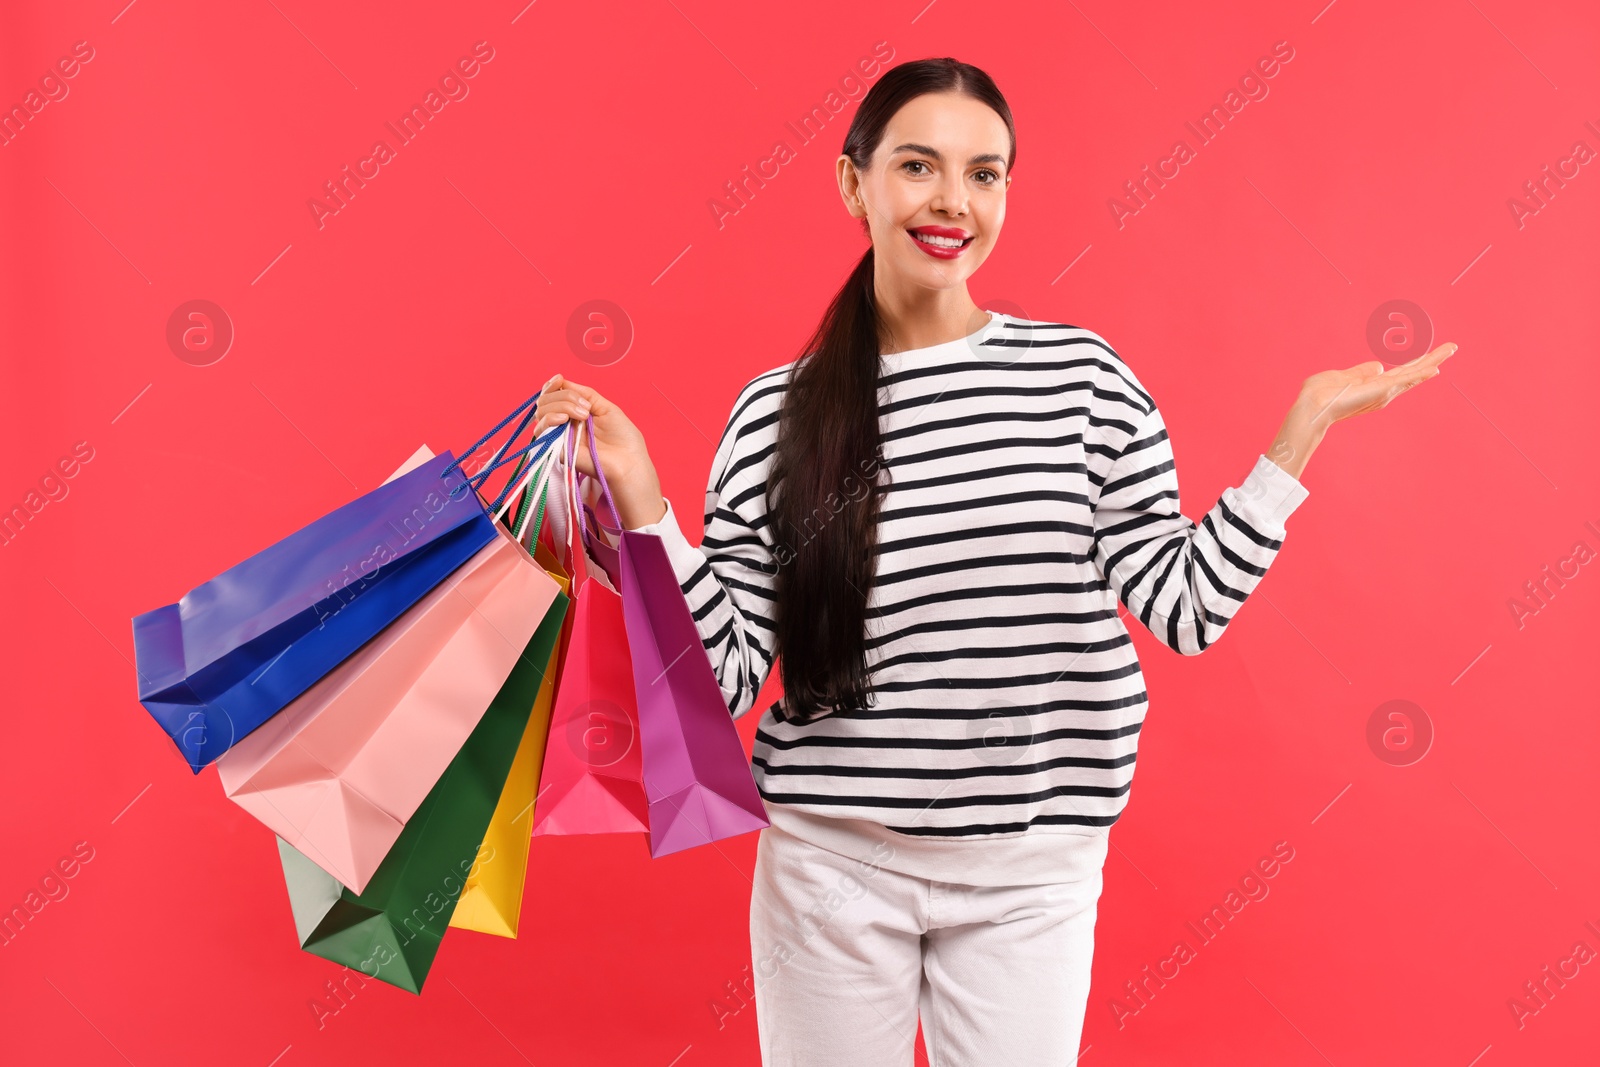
1094, 395, 1309, 656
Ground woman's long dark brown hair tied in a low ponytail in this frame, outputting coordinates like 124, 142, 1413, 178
768, 56, 1016, 723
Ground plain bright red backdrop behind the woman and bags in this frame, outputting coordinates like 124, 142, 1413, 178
0, 0, 1600, 1067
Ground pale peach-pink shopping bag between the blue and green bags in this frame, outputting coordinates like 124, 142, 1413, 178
218, 435, 562, 893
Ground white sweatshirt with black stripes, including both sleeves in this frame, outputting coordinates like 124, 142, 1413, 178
617, 312, 1307, 885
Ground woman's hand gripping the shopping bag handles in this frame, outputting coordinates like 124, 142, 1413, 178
533, 374, 666, 530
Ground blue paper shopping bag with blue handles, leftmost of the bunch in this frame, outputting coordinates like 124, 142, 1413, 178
133, 395, 560, 774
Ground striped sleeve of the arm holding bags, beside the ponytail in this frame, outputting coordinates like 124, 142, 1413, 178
617, 379, 778, 718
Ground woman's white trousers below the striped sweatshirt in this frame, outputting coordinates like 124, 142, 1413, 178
750, 827, 1102, 1067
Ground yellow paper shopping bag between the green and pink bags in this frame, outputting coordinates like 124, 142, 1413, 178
450, 450, 571, 937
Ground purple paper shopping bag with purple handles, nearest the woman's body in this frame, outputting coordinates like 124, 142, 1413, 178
566, 419, 770, 856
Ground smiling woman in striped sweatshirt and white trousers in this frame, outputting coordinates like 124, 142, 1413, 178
538, 59, 1454, 1067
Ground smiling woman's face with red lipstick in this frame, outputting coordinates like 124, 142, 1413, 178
838, 93, 1011, 290
